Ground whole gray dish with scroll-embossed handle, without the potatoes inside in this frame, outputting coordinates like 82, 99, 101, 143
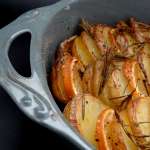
0, 0, 150, 150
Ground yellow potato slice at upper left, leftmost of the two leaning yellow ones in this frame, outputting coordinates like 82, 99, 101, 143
72, 36, 94, 66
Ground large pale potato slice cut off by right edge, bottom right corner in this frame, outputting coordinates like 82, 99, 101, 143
127, 97, 150, 149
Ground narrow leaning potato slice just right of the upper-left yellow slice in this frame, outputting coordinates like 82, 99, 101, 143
81, 32, 101, 60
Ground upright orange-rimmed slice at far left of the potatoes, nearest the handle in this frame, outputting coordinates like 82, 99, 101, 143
62, 54, 83, 100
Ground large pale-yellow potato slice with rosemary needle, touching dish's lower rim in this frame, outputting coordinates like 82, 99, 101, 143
64, 94, 106, 147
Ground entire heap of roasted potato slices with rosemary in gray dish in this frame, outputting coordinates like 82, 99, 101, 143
50, 18, 150, 150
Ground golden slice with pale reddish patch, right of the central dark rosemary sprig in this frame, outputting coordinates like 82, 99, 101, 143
99, 61, 132, 108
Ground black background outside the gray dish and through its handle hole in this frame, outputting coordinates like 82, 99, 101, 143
0, 0, 77, 150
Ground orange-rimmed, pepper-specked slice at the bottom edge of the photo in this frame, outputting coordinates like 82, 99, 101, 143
96, 108, 137, 150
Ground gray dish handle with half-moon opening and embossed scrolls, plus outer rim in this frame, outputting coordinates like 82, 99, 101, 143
0, 0, 94, 150
